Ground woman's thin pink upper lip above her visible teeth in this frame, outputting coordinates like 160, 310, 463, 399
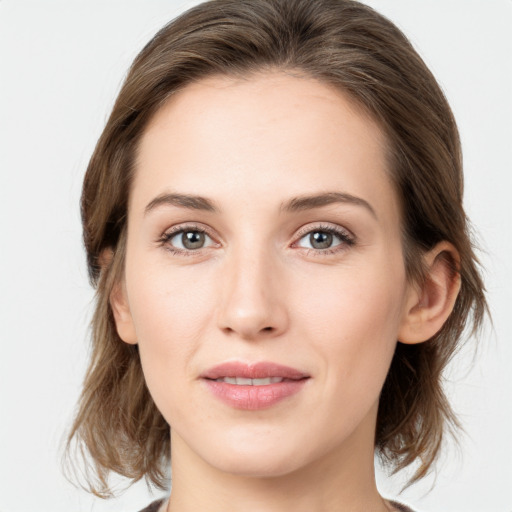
201, 361, 309, 380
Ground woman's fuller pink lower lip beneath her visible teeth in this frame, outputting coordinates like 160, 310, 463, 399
205, 379, 308, 411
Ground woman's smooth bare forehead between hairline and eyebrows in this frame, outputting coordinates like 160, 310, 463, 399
132, 72, 396, 230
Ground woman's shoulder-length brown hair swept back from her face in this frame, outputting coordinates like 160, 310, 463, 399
67, 0, 487, 497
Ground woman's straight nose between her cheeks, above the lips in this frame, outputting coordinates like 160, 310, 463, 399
218, 249, 289, 340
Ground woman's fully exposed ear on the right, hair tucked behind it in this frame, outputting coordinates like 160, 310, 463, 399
398, 242, 460, 344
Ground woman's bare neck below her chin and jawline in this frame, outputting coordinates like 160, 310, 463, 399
168, 404, 392, 512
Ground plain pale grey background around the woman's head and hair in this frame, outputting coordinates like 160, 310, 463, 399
0, 0, 512, 512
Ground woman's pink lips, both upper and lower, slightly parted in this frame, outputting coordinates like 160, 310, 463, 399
201, 362, 309, 411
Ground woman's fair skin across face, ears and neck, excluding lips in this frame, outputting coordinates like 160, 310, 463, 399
111, 72, 458, 512
